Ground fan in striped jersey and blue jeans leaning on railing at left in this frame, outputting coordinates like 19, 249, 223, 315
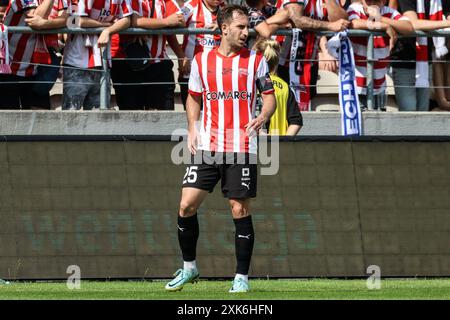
62, 0, 133, 110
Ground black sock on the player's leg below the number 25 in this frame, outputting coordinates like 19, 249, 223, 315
178, 213, 199, 261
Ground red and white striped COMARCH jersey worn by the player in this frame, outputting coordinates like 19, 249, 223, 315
189, 48, 274, 154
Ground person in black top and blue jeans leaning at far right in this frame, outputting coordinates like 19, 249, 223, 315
391, 0, 450, 111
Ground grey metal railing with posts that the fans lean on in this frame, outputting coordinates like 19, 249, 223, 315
8, 27, 450, 110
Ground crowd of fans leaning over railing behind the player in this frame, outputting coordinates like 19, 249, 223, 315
0, 0, 450, 111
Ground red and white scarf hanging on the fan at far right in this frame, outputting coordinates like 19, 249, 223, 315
416, 0, 448, 88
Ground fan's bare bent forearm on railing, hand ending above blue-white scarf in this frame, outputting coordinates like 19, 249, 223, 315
285, 3, 349, 32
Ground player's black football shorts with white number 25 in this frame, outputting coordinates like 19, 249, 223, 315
183, 150, 258, 199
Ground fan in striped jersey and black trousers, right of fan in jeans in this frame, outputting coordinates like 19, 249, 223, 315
111, 0, 184, 110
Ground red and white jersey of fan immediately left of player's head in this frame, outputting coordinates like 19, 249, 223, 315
181, 0, 221, 59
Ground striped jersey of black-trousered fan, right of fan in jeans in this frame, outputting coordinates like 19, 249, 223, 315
132, 0, 180, 63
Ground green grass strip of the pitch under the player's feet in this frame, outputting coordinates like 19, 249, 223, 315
0, 278, 450, 300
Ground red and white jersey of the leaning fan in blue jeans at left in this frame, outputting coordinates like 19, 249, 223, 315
64, 0, 133, 68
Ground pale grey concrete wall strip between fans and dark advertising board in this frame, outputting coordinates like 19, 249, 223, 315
4, 110, 450, 136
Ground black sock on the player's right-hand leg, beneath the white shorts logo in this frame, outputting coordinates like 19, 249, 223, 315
233, 216, 255, 274
